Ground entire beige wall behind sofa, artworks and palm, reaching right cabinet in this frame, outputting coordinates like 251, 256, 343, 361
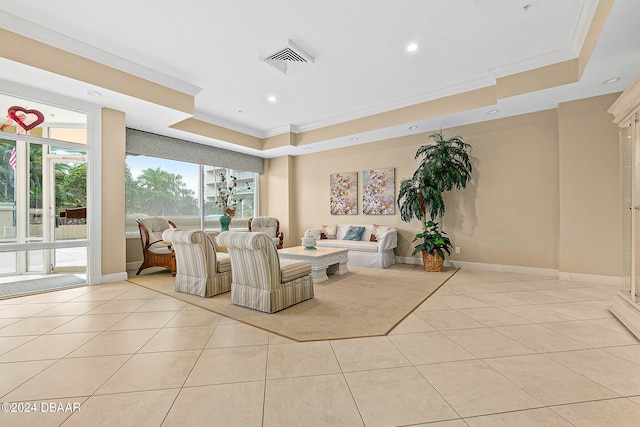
291, 95, 622, 276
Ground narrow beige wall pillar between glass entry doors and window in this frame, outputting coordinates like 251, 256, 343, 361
102, 108, 126, 275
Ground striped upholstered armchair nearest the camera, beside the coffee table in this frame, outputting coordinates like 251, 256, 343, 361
216, 231, 313, 313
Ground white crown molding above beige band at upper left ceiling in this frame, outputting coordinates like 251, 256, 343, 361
0, 11, 202, 96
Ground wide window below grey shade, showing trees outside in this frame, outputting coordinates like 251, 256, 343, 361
126, 153, 257, 234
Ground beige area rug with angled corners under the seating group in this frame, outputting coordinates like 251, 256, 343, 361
128, 264, 457, 341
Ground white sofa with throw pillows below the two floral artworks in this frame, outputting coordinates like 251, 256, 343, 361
311, 224, 398, 268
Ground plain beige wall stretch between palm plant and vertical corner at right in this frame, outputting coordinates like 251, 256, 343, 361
443, 110, 558, 269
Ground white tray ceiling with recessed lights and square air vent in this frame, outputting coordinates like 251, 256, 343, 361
0, 0, 640, 157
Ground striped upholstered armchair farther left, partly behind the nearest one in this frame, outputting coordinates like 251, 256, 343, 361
162, 228, 231, 297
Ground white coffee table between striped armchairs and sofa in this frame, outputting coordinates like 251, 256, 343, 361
278, 246, 349, 284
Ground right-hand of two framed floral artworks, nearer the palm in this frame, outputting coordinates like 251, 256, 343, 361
362, 168, 396, 215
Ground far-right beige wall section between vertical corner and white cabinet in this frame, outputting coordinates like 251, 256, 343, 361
558, 94, 623, 276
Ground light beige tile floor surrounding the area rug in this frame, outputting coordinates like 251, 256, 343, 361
0, 270, 640, 427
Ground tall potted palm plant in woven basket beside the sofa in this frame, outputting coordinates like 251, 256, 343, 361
397, 132, 472, 271
